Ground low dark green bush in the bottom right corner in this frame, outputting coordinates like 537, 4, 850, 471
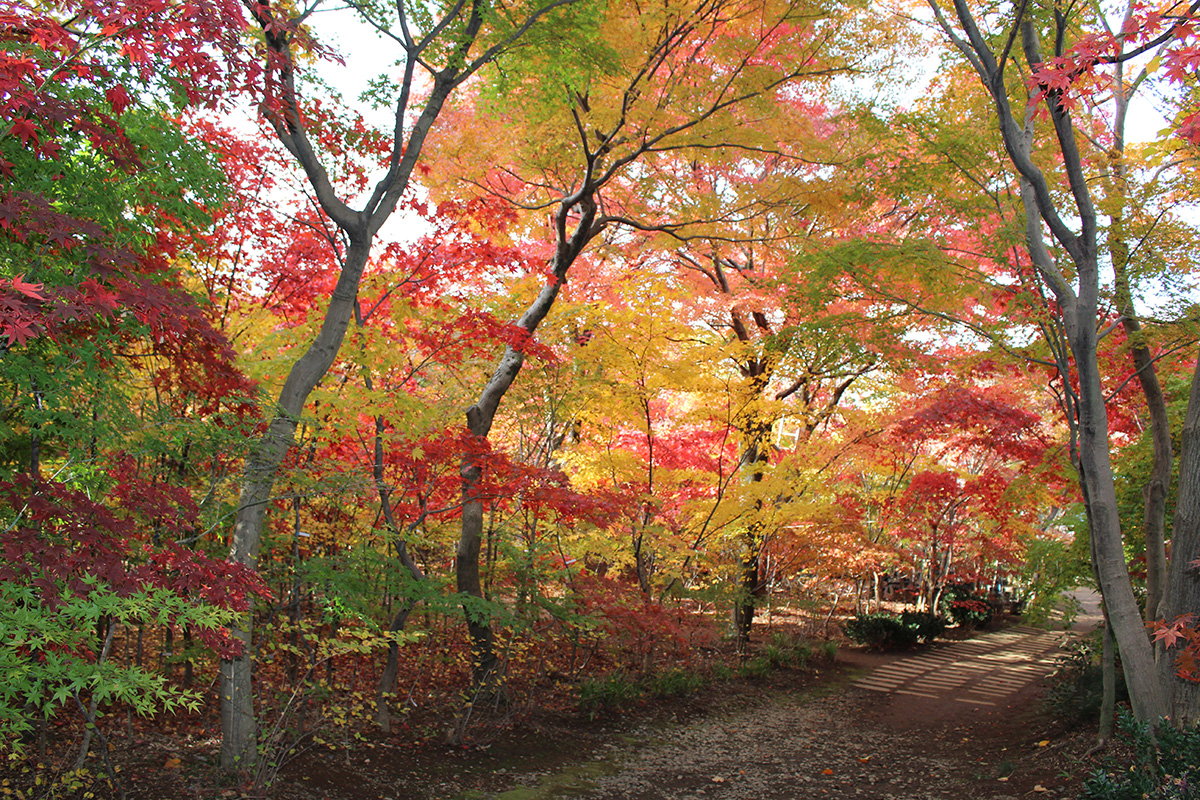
1080, 709, 1200, 800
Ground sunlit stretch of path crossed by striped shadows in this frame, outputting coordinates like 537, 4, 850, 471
853, 625, 1067, 706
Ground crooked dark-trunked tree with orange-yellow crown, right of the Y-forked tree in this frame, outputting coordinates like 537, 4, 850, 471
422, 0, 873, 684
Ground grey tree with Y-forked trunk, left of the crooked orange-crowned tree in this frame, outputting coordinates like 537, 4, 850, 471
213, 0, 600, 771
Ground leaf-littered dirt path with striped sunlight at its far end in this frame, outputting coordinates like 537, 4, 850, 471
477, 627, 1079, 800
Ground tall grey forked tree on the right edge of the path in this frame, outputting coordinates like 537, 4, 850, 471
931, 2, 1200, 724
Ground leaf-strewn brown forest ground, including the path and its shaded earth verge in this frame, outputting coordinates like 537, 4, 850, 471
262, 626, 1093, 800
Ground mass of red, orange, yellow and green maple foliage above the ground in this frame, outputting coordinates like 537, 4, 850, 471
0, 0, 1200, 792
